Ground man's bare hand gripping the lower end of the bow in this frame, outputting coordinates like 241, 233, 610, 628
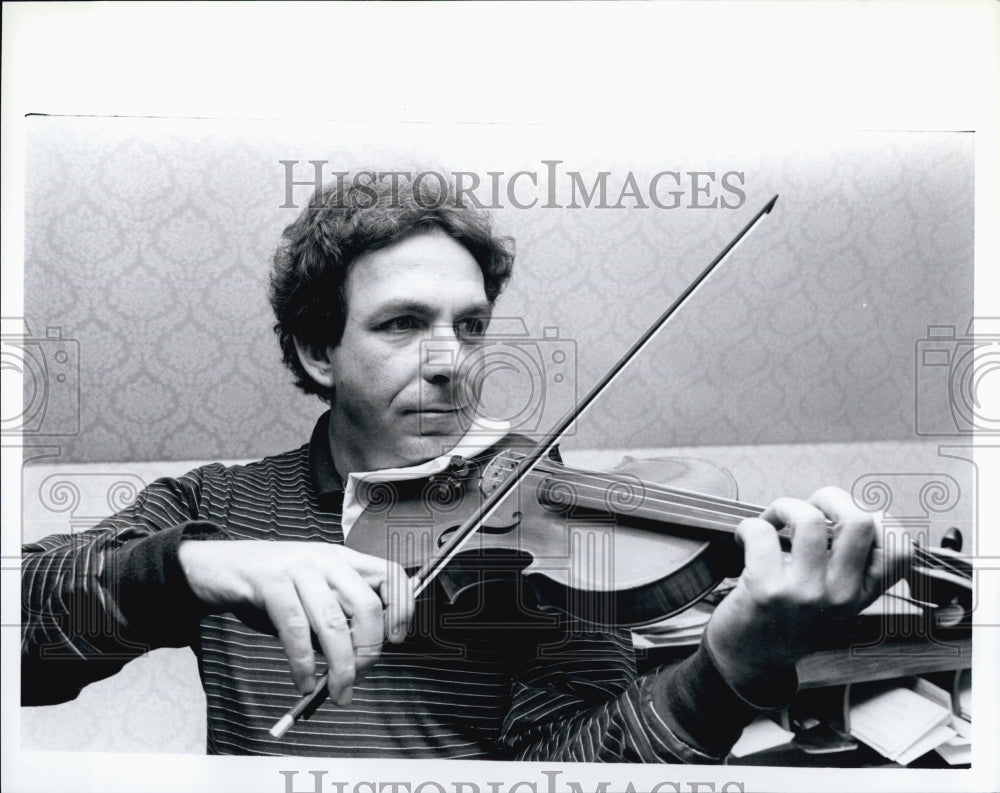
179, 540, 413, 705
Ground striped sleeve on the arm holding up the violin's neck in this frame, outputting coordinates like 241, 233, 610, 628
502, 616, 797, 763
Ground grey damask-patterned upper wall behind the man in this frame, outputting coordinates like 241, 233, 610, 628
17, 117, 973, 462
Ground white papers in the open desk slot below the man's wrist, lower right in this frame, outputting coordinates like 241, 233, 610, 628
851, 687, 958, 765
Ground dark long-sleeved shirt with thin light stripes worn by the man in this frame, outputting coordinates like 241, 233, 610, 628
22, 416, 794, 762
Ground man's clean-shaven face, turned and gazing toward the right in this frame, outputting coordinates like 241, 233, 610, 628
328, 230, 492, 474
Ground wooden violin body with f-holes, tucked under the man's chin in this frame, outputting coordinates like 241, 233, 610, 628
347, 450, 742, 627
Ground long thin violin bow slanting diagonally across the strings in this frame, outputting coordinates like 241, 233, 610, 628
269, 195, 778, 738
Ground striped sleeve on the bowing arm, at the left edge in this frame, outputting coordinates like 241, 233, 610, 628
21, 470, 222, 705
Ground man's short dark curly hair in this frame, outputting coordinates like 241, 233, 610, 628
270, 171, 514, 401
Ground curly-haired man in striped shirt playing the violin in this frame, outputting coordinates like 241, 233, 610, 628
22, 172, 906, 762
